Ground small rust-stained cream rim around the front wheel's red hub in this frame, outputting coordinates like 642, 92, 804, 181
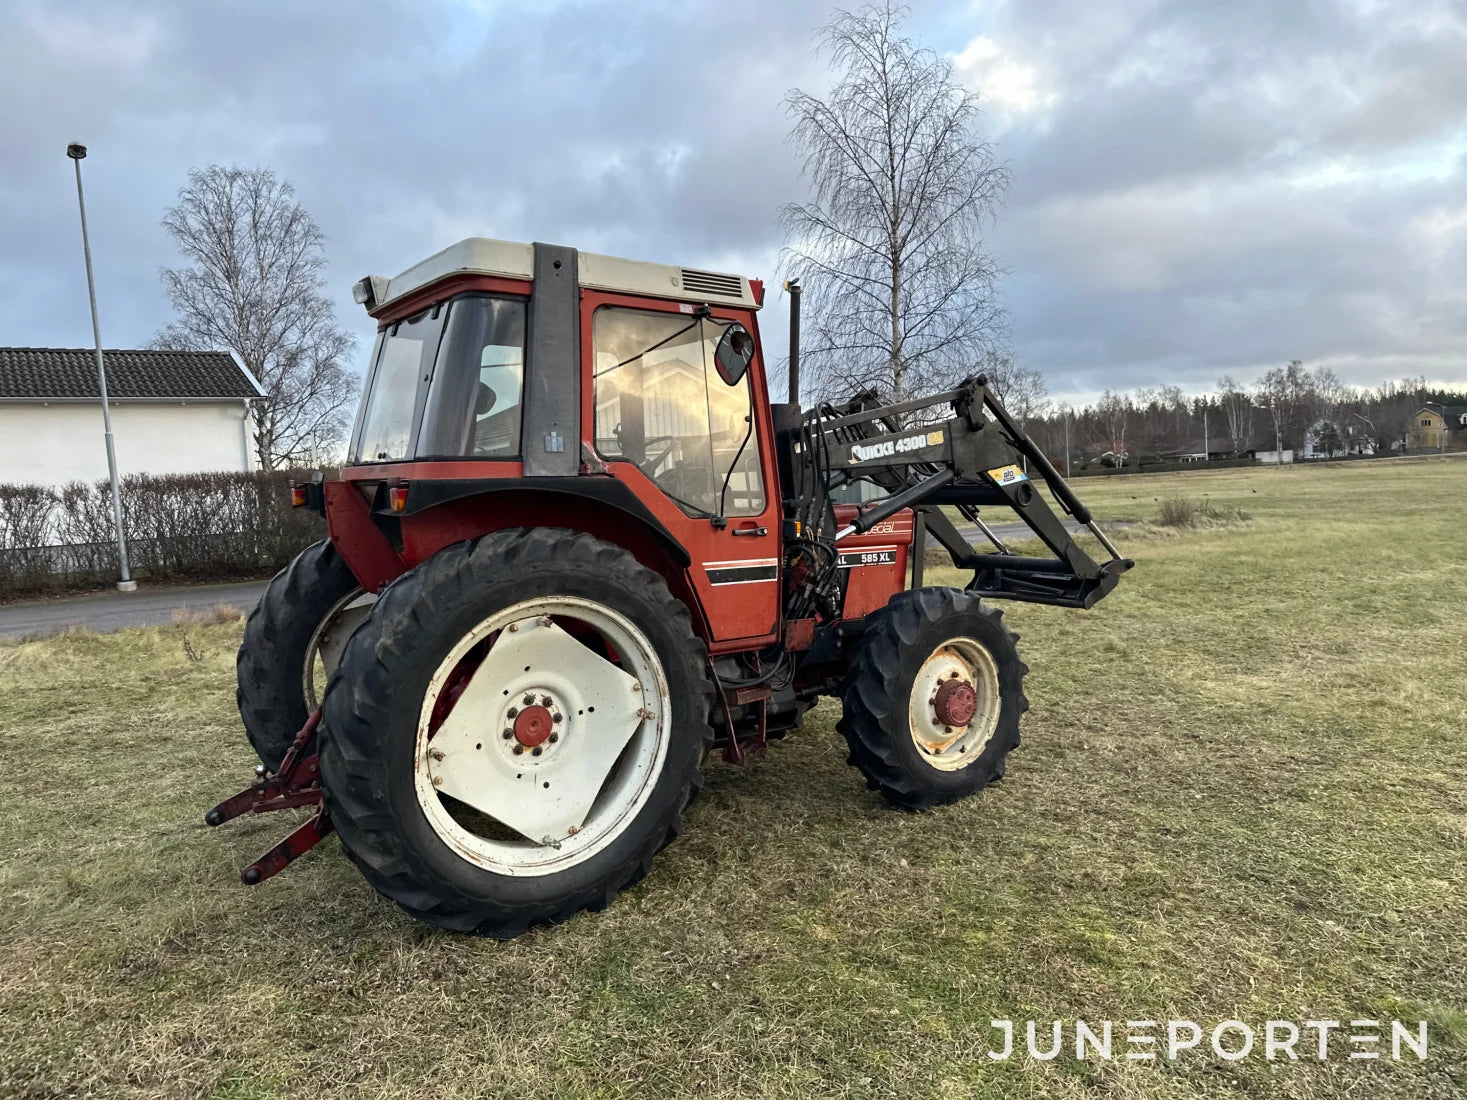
907, 638, 1003, 771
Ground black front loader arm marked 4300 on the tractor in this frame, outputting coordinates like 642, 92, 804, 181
789, 375, 1134, 607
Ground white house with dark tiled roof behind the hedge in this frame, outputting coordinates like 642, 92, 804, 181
0, 348, 264, 485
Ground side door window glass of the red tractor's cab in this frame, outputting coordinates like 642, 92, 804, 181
593, 307, 764, 516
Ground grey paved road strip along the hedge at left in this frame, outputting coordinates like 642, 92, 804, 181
0, 581, 266, 638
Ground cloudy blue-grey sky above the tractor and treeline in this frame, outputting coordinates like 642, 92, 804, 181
0, 0, 1467, 399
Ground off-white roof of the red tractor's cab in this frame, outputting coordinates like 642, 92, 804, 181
362, 236, 760, 314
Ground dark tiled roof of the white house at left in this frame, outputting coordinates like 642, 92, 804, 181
0, 348, 266, 402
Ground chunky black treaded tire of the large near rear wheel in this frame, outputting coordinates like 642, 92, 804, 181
321, 528, 713, 939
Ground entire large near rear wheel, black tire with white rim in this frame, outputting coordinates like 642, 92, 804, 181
320, 528, 713, 939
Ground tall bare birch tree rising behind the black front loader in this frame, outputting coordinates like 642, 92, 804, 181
780, 0, 1008, 400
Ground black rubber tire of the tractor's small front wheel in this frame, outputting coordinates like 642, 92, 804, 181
838, 587, 1028, 810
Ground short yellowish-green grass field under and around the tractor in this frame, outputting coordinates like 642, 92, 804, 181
0, 462, 1467, 1100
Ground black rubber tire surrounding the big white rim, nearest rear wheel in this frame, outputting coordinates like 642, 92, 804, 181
320, 528, 713, 939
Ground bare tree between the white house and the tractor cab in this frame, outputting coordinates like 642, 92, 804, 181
154, 164, 358, 469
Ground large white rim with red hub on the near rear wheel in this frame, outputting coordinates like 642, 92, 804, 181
414, 595, 673, 876
